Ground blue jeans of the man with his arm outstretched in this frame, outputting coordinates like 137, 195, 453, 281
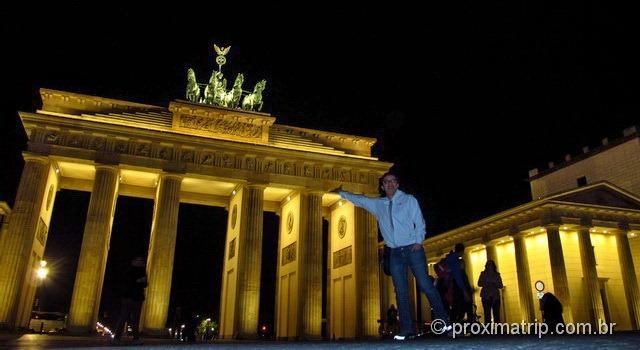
391, 246, 449, 334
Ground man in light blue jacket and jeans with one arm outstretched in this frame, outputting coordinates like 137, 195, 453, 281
337, 172, 450, 340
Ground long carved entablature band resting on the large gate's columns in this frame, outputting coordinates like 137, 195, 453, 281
20, 112, 391, 192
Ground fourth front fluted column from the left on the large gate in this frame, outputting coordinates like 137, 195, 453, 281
235, 185, 265, 339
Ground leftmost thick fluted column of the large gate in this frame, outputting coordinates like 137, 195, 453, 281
0, 154, 50, 327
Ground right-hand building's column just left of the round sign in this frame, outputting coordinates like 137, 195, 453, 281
512, 233, 535, 322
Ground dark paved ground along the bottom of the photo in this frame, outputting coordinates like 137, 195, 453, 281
0, 332, 640, 350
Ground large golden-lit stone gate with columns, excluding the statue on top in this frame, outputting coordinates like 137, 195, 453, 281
0, 89, 391, 339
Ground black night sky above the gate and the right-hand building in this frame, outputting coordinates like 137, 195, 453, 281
0, 1, 640, 326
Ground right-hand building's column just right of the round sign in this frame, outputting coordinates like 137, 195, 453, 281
545, 224, 573, 323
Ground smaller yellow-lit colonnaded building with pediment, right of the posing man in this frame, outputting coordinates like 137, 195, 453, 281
388, 127, 640, 330
